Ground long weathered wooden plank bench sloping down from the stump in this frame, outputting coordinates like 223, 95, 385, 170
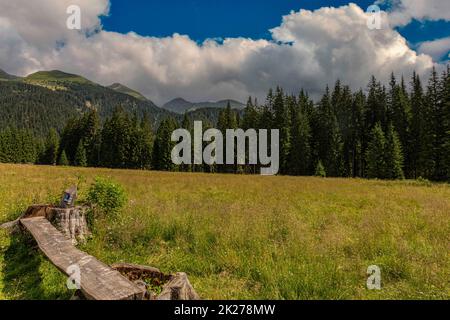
20, 217, 144, 300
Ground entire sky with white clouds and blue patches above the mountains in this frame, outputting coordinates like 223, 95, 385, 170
0, 0, 450, 105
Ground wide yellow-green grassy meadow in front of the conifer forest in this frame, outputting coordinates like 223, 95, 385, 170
0, 165, 450, 299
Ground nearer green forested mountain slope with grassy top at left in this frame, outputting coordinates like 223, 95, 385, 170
0, 71, 174, 135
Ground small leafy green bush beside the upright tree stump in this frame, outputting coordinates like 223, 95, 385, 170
87, 177, 127, 215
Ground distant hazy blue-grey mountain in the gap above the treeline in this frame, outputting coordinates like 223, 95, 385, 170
163, 98, 245, 114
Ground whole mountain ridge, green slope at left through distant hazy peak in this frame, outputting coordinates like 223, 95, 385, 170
0, 70, 244, 137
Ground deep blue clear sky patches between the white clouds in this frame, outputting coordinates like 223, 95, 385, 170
102, 0, 450, 47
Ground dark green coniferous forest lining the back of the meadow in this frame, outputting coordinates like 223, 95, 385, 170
0, 67, 450, 181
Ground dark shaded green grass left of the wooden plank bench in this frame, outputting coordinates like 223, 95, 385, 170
1, 232, 72, 300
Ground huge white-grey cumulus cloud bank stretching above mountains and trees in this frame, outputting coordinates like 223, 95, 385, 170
0, 0, 442, 104
